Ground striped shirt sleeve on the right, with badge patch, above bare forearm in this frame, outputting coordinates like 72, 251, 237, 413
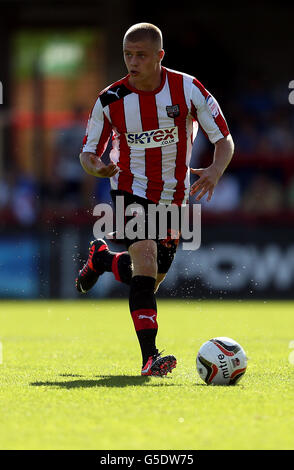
191, 78, 230, 144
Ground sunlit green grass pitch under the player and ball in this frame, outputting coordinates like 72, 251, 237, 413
0, 300, 294, 450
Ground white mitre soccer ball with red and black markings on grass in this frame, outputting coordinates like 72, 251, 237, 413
196, 336, 247, 385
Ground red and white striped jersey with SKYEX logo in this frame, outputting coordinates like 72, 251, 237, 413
82, 67, 230, 205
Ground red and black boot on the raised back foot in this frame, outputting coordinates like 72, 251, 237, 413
76, 239, 108, 294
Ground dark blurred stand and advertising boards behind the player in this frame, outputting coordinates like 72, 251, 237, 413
0, 0, 294, 300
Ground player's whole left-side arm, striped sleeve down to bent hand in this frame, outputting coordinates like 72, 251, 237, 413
80, 98, 119, 178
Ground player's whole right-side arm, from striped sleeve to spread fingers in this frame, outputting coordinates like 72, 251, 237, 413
190, 79, 234, 201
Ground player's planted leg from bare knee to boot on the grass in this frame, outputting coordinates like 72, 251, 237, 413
129, 240, 176, 376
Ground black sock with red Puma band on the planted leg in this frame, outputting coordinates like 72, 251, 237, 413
129, 276, 158, 366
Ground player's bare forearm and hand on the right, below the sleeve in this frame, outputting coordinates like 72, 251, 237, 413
190, 134, 234, 201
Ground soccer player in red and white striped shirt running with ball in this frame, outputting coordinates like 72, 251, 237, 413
76, 23, 234, 376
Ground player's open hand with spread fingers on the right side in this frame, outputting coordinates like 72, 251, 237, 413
190, 165, 222, 202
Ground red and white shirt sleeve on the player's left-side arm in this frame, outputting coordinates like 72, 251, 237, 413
82, 97, 112, 157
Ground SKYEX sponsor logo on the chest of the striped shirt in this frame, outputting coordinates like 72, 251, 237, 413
125, 126, 179, 149
